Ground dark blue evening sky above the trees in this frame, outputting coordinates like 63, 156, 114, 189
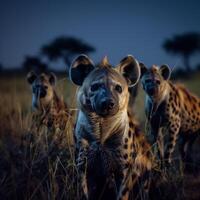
0, 0, 200, 69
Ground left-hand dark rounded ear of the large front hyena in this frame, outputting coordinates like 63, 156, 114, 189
69, 55, 94, 85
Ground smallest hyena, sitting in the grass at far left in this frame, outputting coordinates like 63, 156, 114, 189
27, 71, 73, 146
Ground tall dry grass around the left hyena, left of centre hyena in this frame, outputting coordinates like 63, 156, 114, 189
0, 74, 80, 199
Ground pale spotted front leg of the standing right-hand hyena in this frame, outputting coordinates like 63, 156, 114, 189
165, 118, 180, 164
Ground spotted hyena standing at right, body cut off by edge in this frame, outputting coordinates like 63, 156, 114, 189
140, 63, 200, 167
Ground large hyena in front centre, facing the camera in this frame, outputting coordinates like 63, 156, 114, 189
70, 55, 152, 199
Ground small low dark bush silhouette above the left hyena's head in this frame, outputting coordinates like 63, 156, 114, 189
22, 56, 48, 73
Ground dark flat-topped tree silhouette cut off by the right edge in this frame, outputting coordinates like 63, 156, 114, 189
163, 33, 200, 71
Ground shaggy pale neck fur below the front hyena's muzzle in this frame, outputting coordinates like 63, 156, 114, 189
78, 110, 128, 144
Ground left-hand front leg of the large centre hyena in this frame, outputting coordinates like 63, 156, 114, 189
76, 141, 88, 199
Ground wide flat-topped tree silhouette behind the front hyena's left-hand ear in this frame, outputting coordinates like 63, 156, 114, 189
41, 36, 95, 69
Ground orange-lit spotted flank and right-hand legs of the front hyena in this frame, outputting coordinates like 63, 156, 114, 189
119, 113, 153, 199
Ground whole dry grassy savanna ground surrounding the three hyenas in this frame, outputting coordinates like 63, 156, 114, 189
0, 73, 200, 200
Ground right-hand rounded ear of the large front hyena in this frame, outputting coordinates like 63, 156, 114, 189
119, 55, 140, 87
